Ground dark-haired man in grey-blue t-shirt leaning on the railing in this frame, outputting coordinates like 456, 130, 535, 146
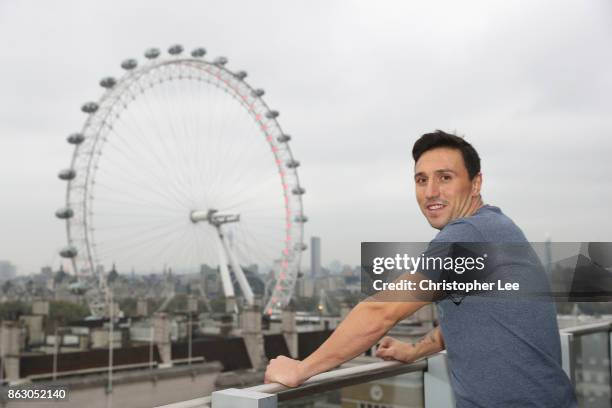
265, 131, 577, 408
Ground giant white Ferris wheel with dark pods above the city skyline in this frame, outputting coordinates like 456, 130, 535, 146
56, 45, 307, 315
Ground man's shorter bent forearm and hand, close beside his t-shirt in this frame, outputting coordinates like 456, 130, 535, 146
376, 326, 445, 363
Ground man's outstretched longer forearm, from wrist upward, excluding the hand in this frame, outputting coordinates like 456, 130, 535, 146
300, 302, 428, 378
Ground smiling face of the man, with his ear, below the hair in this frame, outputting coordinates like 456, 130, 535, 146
414, 147, 482, 229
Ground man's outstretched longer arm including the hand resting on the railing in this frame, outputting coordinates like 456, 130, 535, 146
265, 300, 431, 387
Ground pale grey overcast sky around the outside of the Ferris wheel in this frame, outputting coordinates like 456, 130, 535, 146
0, 0, 612, 273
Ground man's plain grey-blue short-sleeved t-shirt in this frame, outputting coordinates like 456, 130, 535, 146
426, 205, 578, 408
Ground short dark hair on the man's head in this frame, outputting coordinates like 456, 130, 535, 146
412, 130, 480, 180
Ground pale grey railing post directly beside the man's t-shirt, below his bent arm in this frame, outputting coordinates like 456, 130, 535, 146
423, 352, 455, 408
